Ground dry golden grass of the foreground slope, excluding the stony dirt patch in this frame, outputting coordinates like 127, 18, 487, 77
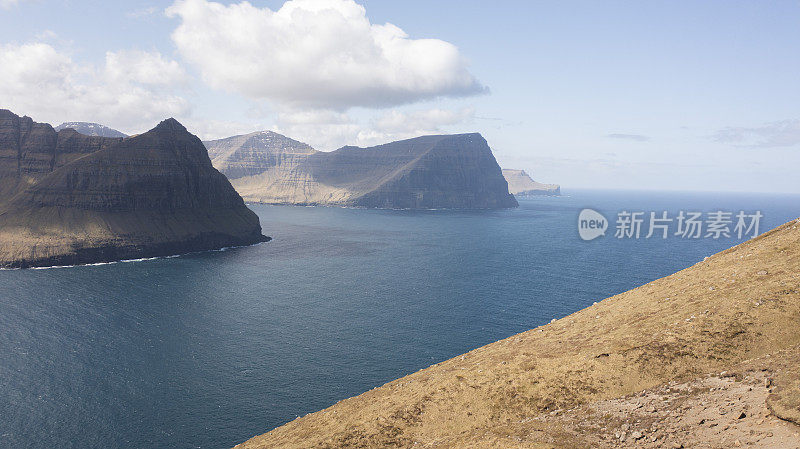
237, 216, 800, 449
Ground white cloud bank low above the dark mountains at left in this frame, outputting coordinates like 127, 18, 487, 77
0, 43, 188, 133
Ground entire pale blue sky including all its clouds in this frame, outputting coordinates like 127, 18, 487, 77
0, 0, 800, 193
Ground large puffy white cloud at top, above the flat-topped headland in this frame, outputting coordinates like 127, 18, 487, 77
166, 0, 486, 110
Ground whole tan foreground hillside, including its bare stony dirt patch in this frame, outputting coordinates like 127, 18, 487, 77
237, 219, 800, 449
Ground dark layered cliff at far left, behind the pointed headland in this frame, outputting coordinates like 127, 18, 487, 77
0, 109, 122, 198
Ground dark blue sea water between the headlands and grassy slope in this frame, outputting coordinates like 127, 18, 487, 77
0, 192, 800, 448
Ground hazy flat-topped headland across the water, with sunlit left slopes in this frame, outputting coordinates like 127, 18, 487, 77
206, 133, 517, 209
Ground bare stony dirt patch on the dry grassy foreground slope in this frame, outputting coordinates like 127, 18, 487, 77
548, 364, 800, 449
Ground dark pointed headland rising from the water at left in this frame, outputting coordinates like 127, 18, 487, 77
0, 110, 268, 267
